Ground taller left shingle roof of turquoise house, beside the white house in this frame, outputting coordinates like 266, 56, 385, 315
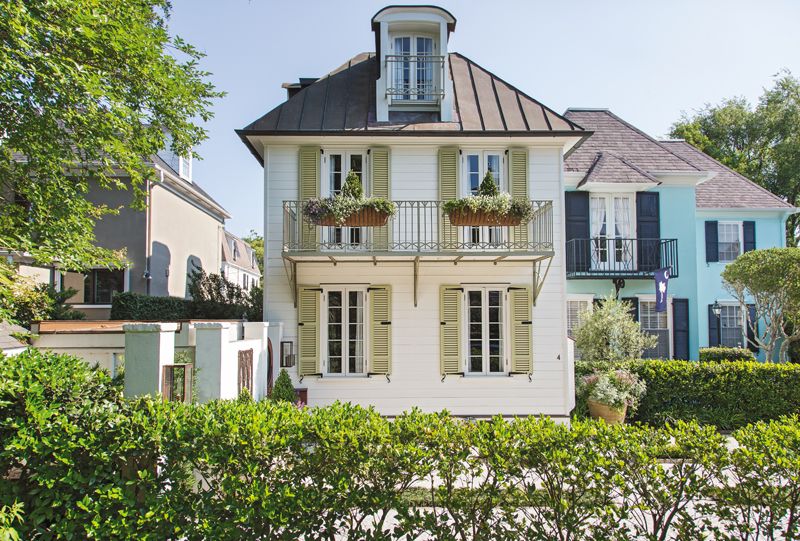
564, 109, 698, 173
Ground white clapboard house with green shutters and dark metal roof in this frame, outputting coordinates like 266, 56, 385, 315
238, 6, 590, 418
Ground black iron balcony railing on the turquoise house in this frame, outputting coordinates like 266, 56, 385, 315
566, 237, 678, 278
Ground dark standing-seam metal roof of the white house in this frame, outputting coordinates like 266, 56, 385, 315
239, 53, 585, 135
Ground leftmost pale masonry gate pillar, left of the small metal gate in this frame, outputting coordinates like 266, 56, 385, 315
122, 323, 178, 398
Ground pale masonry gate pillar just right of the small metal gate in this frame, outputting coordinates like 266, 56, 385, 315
194, 322, 231, 404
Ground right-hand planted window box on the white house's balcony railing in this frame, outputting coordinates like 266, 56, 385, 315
442, 171, 533, 226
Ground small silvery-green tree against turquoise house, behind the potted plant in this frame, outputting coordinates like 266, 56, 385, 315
574, 295, 658, 363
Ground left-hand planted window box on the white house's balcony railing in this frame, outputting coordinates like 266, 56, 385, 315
303, 171, 397, 227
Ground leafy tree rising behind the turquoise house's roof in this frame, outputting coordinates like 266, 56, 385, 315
670, 71, 800, 246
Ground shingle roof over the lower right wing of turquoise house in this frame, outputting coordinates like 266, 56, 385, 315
662, 140, 793, 209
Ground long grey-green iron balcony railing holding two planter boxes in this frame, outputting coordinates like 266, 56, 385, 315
283, 201, 553, 256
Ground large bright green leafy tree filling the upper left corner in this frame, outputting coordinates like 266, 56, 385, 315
0, 0, 222, 270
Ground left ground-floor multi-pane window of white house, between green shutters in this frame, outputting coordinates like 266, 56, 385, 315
327, 289, 366, 375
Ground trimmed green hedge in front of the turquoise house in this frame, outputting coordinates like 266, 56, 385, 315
575, 360, 800, 430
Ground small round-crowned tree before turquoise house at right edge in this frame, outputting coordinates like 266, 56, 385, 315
722, 248, 800, 362
